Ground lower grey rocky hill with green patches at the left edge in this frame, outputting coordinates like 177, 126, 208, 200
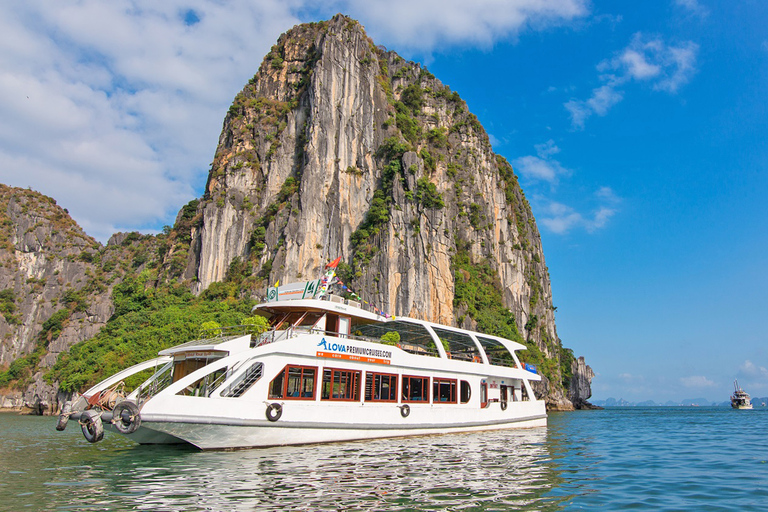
0, 185, 158, 413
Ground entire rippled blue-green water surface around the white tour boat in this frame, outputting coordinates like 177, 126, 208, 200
0, 408, 768, 511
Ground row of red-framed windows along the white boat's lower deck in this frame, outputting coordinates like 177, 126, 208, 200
269, 365, 472, 404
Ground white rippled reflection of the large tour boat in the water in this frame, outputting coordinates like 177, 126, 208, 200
93, 428, 559, 510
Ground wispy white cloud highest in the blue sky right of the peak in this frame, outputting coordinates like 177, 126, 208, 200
563, 33, 699, 129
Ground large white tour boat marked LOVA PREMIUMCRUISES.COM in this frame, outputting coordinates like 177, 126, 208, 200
57, 278, 547, 449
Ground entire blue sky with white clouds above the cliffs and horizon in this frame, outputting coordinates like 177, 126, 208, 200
0, 0, 768, 402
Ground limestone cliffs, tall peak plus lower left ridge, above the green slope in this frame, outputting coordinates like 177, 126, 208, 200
0, 15, 593, 409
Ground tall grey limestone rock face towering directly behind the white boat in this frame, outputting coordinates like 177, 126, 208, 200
181, 15, 589, 408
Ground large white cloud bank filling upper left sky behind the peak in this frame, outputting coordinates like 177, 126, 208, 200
0, 0, 588, 241
